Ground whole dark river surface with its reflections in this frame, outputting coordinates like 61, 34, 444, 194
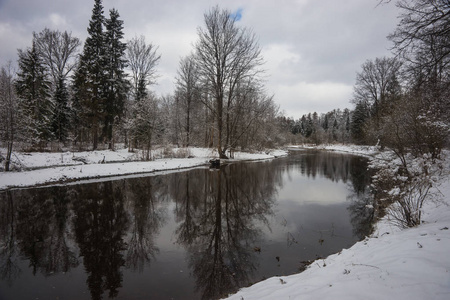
0, 151, 371, 300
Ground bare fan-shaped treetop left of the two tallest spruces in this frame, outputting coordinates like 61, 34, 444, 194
33, 28, 81, 87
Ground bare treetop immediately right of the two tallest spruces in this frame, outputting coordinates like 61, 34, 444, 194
126, 36, 161, 100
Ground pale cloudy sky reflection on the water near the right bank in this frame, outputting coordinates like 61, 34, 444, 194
251, 158, 356, 277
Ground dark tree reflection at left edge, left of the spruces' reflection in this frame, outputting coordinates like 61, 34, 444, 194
1, 188, 79, 278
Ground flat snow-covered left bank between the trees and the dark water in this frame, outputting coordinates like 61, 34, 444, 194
0, 148, 287, 189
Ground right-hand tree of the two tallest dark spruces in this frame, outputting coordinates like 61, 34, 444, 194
103, 9, 129, 149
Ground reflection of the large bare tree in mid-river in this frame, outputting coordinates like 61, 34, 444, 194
171, 164, 281, 299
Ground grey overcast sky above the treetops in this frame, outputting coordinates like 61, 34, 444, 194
0, 0, 398, 119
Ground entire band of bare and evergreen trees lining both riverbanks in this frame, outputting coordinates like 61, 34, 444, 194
0, 0, 450, 171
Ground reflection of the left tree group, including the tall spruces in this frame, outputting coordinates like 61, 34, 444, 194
0, 177, 168, 299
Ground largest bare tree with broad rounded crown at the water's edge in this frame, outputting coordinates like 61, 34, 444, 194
195, 6, 263, 158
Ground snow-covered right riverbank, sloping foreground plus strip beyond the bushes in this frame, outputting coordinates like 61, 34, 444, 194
228, 145, 450, 300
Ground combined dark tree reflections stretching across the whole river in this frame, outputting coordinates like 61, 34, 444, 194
0, 152, 373, 299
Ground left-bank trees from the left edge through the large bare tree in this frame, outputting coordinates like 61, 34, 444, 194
0, 0, 288, 169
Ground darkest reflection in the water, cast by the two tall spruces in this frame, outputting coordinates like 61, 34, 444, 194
74, 181, 128, 300
